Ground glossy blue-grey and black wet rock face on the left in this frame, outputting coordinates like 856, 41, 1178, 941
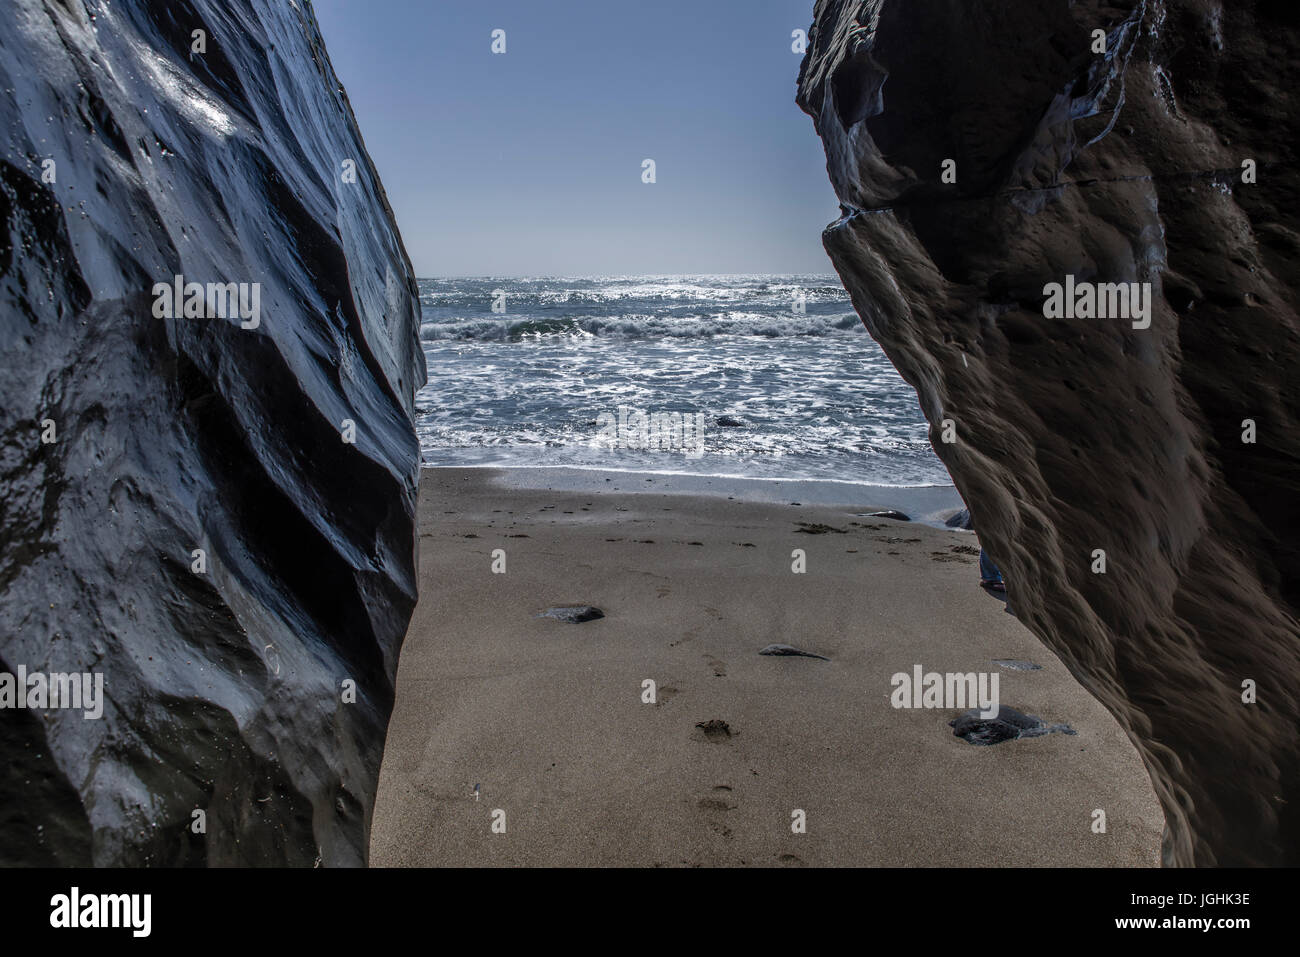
0, 0, 424, 866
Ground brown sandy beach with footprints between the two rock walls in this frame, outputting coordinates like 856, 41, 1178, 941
371, 468, 1164, 866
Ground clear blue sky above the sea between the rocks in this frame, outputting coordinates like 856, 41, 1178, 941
313, 0, 839, 277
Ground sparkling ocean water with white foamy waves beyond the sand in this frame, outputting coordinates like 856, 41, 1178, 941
416, 276, 950, 486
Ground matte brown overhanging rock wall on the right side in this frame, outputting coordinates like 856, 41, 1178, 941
798, 0, 1300, 865
